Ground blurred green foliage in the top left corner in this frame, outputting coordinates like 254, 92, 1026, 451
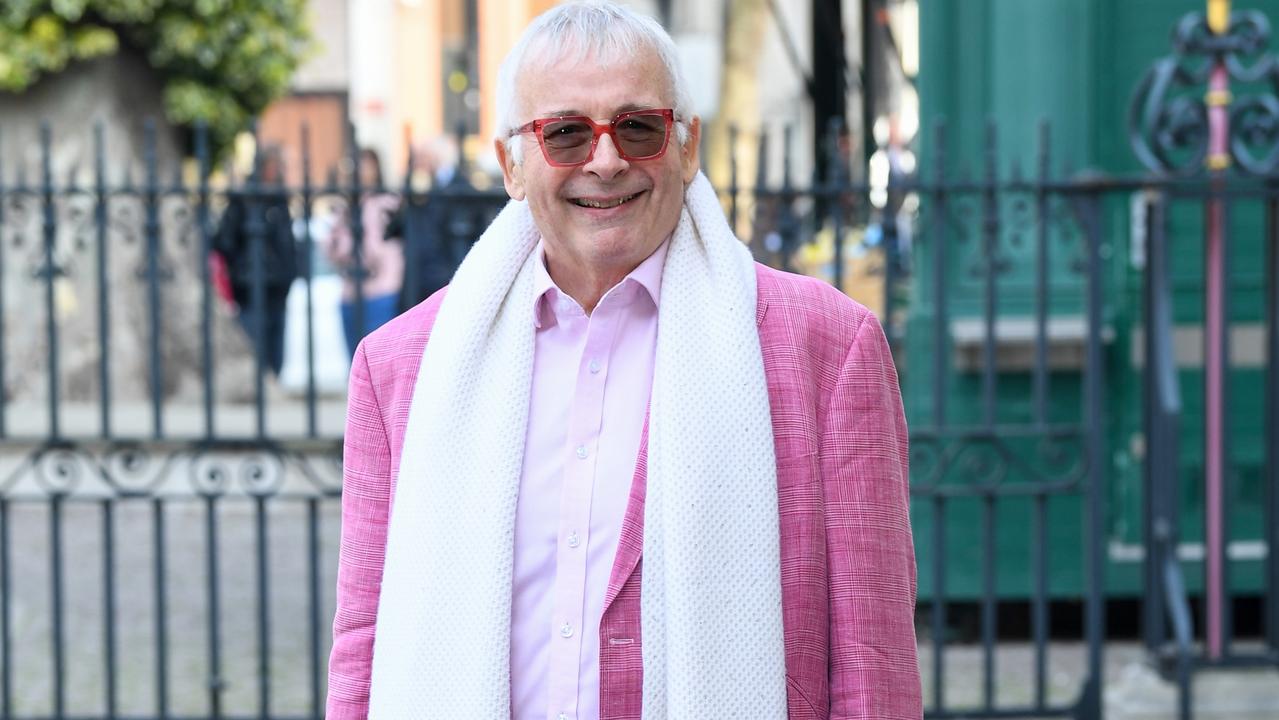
0, 0, 311, 154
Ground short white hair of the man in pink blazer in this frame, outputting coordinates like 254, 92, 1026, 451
498, 0, 693, 164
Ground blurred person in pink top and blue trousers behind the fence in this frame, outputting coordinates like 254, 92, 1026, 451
325, 148, 404, 356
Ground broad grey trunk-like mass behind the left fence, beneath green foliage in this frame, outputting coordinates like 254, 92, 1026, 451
0, 52, 263, 411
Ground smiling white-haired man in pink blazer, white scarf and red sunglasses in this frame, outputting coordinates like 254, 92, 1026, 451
327, 3, 921, 720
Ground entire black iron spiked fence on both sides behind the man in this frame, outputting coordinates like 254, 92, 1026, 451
0, 108, 1279, 719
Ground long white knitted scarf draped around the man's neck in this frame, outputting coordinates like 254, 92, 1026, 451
370, 174, 787, 720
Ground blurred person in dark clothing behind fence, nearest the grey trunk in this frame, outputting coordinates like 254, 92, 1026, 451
212, 146, 298, 375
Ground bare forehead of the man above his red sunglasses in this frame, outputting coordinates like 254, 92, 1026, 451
518, 49, 673, 119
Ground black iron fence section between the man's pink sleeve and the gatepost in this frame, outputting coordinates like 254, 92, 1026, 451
900, 127, 1111, 717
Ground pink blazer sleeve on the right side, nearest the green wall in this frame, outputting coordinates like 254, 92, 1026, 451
821, 313, 923, 720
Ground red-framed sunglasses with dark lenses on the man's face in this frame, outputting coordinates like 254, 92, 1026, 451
510, 107, 675, 168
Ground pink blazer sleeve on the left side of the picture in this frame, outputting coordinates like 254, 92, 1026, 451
325, 343, 393, 720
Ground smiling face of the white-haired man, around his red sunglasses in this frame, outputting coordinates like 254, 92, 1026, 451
498, 50, 700, 281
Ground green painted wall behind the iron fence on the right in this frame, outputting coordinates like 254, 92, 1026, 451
903, 0, 1279, 597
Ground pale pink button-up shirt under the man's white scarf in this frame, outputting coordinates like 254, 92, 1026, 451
510, 243, 668, 720
